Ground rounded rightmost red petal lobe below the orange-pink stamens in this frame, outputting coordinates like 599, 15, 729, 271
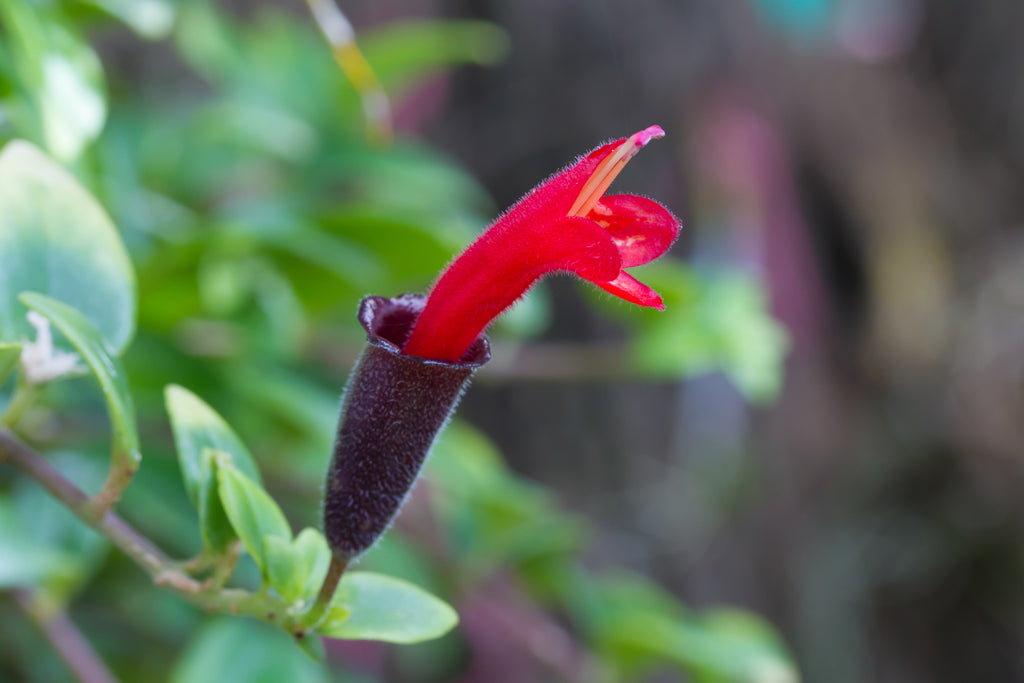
587, 195, 679, 268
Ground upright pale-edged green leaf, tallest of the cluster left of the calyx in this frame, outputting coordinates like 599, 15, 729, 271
164, 384, 260, 506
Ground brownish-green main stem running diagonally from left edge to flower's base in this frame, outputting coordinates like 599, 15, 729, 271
0, 429, 296, 633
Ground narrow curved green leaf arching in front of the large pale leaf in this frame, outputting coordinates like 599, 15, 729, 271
19, 292, 142, 468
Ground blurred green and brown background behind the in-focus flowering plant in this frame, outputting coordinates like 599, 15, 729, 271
0, 0, 1024, 683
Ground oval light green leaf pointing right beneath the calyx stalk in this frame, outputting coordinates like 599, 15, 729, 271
317, 571, 459, 643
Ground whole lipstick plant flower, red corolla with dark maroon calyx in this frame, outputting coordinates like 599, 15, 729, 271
324, 126, 679, 573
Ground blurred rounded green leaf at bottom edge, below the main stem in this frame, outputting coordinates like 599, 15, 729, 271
170, 617, 330, 683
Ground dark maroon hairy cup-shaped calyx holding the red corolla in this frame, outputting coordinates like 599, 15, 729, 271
324, 294, 490, 559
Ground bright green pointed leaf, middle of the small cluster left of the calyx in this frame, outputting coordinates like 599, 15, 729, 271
216, 458, 292, 575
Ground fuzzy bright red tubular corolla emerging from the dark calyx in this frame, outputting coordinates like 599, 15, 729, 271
402, 126, 679, 361
